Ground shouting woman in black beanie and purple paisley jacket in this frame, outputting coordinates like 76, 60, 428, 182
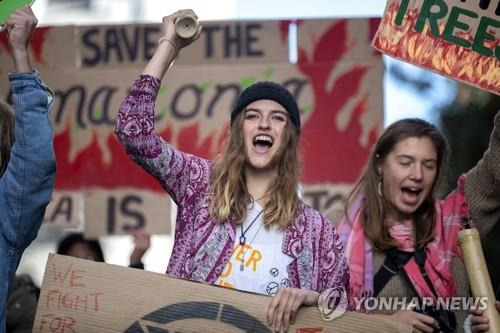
116, 10, 349, 330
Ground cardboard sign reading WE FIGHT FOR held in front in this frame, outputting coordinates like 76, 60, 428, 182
33, 254, 411, 333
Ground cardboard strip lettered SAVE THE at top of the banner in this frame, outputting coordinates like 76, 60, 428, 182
78, 21, 288, 68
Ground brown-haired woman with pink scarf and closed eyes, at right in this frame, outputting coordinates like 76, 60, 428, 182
326, 114, 500, 332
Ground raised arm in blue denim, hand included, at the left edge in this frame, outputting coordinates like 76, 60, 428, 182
0, 6, 55, 326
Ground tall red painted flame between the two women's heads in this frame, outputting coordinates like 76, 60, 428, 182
298, 20, 377, 184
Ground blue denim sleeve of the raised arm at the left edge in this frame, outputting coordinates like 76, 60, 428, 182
0, 71, 55, 255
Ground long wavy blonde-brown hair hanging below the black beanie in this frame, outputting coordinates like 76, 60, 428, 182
210, 111, 301, 230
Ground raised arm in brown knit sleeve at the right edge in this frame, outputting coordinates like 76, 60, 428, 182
465, 112, 500, 238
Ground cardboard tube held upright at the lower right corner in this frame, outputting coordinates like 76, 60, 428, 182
458, 229, 500, 333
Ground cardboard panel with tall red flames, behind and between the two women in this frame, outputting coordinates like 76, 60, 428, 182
296, 19, 384, 185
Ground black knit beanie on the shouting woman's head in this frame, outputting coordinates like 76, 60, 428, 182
231, 81, 300, 134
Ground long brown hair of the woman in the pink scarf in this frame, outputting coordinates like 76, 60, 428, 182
345, 118, 448, 250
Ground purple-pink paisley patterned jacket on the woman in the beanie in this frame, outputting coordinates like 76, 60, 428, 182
116, 75, 349, 292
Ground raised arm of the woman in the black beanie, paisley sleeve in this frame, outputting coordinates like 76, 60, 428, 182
115, 10, 206, 205
